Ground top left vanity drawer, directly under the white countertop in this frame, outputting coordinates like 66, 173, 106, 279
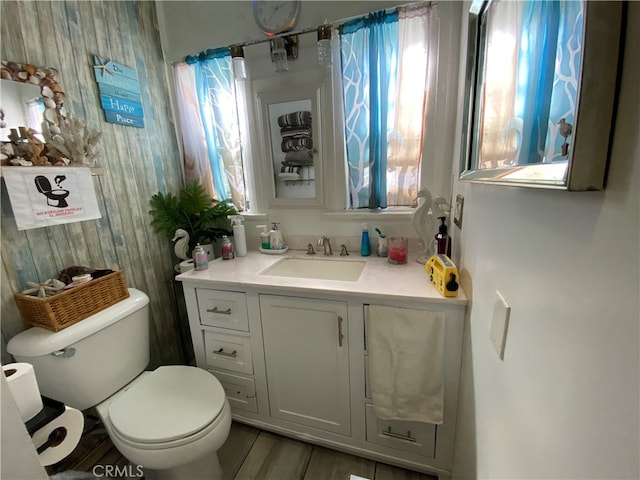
196, 288, 249, 332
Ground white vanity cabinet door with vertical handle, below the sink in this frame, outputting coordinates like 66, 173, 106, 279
260, 295, 351, 435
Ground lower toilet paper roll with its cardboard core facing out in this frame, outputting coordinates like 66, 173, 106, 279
31, 407, 84, 467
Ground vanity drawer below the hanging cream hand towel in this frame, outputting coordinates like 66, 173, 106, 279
366, 405, 436, 458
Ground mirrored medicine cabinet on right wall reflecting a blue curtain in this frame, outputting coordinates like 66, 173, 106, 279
460, 0, 622, 190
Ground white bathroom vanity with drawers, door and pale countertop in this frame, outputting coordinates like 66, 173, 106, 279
179, 253, 467, 478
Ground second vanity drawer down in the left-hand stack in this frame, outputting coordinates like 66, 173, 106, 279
204, 332, 253, 375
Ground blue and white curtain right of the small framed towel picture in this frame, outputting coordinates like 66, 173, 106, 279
339, 5, 430, 208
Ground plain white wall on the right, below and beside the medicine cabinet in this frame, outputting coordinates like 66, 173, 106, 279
453, 2, 640, 479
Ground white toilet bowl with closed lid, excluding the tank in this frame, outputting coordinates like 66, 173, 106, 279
95, 366, 231, 480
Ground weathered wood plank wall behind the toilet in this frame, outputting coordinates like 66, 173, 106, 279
0, 0, 188, 366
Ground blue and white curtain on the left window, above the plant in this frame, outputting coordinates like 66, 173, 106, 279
174, 48, 245, 210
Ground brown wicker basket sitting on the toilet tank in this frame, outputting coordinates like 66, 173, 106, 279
16, 272, 129, 332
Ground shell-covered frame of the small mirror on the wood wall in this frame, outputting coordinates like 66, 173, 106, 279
0, 60, 66, 131
